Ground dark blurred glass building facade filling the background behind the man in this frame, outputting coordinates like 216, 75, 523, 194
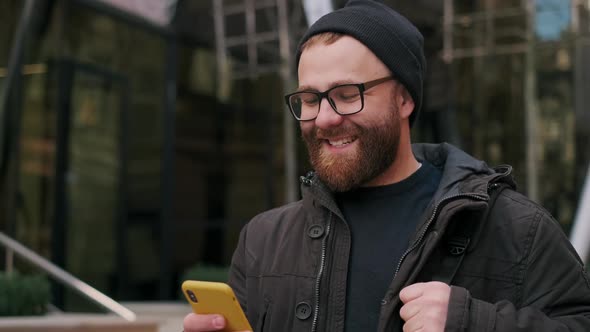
0, 0, 590, 316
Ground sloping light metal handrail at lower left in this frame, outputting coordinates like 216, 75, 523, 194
0, 232, 137, 322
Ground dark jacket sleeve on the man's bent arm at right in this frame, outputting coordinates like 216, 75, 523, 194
445, 209, 590, 332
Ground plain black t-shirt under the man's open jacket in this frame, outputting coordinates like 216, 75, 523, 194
336, 162, 441, 332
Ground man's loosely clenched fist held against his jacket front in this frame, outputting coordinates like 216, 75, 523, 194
399, 281, 451, 332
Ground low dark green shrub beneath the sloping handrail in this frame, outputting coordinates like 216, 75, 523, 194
0, 272, 50, 316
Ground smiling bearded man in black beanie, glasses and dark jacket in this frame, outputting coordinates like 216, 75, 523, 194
184, 0, 590, 332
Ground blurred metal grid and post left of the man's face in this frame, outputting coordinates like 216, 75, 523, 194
212, 0, 312, 202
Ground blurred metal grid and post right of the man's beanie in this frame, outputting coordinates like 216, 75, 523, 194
442, 0, 590, 201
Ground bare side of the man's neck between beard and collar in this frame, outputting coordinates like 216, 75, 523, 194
364, 126, 420, 187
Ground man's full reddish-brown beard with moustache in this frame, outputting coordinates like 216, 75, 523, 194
302, 104, 400, 192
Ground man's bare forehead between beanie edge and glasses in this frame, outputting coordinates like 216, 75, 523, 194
298, 36, 389, 89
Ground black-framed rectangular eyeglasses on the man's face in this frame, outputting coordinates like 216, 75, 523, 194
285, 76, 394, 121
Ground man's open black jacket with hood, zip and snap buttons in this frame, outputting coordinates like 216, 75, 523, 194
230, 144, 590, 332
